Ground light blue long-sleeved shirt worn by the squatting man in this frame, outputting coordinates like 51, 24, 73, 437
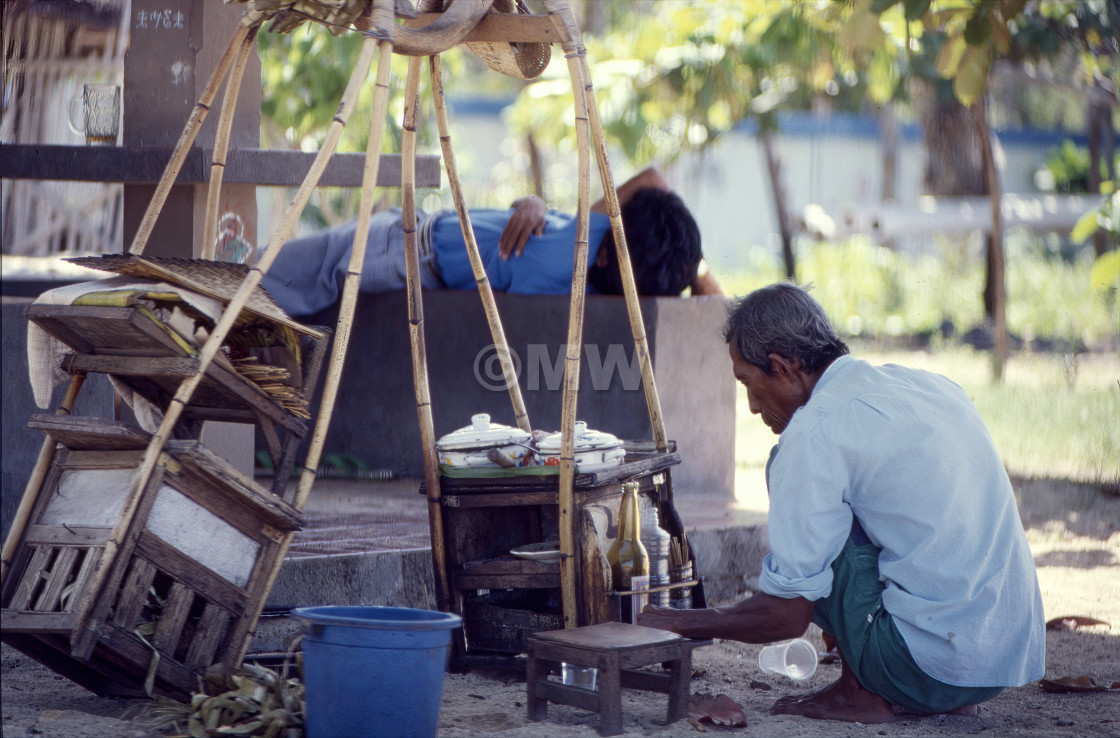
759, 356, 1046, 686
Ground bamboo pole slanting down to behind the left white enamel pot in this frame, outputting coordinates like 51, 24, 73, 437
428, 56, 532, 431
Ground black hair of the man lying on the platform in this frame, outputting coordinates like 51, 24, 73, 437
588, 187, 703, 296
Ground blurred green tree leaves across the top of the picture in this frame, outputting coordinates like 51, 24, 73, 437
260, 0, 1120, 179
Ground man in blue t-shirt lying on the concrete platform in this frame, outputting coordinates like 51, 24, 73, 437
261, 167, 721, 316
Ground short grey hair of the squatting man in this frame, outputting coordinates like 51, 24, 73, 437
724, 282, 848, 374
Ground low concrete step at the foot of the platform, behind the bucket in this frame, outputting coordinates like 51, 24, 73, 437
249, 478, 769, 654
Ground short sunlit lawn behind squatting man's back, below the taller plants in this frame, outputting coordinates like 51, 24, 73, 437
736, 345, 1120, 483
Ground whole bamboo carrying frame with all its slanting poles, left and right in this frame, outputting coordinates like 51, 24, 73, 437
0, 0, 669, 694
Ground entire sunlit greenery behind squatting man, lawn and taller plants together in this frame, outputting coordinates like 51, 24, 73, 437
716, 232, 1120, 483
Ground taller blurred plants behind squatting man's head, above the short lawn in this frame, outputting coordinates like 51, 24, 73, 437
716, 233, 1120, 347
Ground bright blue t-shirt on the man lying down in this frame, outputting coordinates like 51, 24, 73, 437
431, 209, 610, 295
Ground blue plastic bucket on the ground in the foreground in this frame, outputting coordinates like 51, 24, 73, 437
292, 606, 463, 738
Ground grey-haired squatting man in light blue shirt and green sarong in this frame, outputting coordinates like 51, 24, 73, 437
638, 283, 1045, 722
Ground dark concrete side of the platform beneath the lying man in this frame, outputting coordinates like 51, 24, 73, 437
293, 290, 735, 497
